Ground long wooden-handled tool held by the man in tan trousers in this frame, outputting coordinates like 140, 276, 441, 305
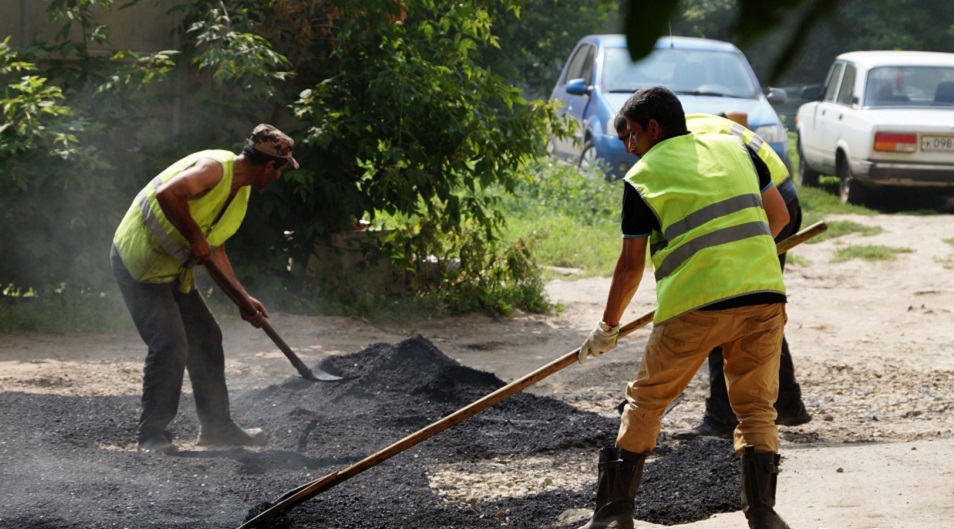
238, 221, 828, 529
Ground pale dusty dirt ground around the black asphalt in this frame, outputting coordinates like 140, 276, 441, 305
0, 211, 954, 529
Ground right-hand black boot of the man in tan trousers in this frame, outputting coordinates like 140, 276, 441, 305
742, 445, 791, 529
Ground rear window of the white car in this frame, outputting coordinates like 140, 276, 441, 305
864, 66, 954, 107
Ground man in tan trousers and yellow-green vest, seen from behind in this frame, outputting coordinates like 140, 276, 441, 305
579, 86, 789, 529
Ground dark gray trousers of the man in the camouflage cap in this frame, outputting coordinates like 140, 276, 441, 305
110, 246, 231, 441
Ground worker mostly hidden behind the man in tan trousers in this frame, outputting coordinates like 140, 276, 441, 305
615, 112, 812, 440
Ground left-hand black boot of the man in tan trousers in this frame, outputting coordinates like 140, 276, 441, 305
579, 448, 649, 529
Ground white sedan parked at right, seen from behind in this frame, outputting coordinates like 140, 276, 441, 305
795, 51, 954, 204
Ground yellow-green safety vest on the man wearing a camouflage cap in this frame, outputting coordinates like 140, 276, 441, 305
113, 150, 251, 292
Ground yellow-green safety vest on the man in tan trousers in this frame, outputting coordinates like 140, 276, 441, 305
625, 134, 785, 323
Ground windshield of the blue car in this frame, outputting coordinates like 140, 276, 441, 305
601, 48, 758, 99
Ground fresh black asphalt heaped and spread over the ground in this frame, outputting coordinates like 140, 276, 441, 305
0, 337, 741, 529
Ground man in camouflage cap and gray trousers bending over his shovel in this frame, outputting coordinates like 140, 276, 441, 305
110, 124, 298, 453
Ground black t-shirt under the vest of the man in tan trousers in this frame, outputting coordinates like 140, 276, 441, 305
621, 136, 786, 310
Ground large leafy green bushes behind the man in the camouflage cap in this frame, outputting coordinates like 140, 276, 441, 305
0, 0, 562, 320
